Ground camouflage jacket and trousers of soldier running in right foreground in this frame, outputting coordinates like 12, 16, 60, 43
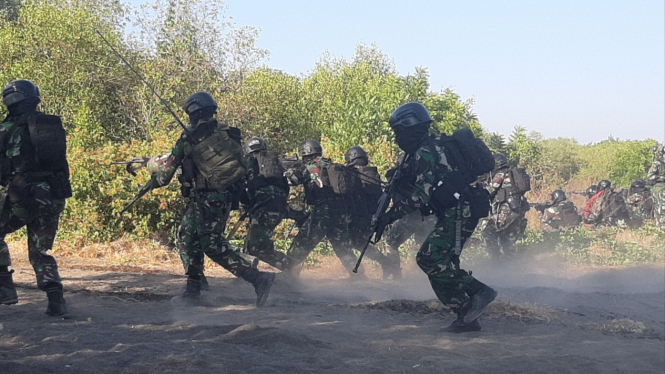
394, 136, 480, 311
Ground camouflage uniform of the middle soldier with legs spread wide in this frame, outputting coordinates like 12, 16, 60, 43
288, 156, 361, 275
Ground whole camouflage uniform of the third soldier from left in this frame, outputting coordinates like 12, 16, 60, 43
245, 153, 293, 270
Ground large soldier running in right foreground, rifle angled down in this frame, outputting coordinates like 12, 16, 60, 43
382, 103, 497, 333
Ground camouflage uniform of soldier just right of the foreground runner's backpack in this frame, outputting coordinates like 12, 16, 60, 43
481, 168, 527, 259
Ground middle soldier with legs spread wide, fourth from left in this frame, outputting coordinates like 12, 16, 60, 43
287, 139, 365, 279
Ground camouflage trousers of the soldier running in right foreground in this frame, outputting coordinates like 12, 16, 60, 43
416, 205, 479, 311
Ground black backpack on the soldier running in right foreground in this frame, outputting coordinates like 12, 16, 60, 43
431, 129, 494, 213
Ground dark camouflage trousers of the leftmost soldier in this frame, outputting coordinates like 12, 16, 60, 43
0, 188, 65, 290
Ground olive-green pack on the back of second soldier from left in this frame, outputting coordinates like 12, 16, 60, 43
189, 124, 245, 191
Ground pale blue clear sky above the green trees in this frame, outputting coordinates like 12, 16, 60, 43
130, 0, 665, 143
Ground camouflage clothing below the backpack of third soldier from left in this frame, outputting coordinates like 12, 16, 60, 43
245, 186, 293, 270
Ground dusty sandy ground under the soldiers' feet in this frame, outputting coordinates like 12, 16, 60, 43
0, 254, 665, 374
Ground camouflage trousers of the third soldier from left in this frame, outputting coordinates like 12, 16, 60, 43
245, 209, 294, 270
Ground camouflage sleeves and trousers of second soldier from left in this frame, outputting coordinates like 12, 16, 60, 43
148, 119, 251, 282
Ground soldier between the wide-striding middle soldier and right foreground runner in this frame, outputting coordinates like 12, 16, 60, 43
344, 146, 402, 280
